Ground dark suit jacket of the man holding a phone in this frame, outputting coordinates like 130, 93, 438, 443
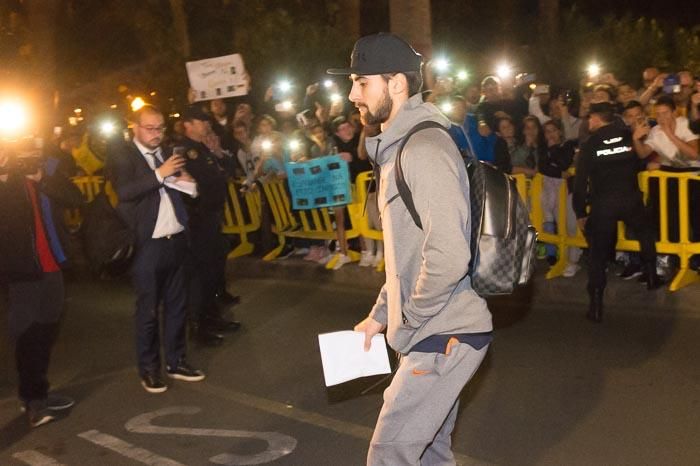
105, 142, 187, 243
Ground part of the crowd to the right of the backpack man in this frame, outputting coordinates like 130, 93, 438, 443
427, 67, 700, 279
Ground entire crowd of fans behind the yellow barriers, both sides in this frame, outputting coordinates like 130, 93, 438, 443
49, 63, 700, 278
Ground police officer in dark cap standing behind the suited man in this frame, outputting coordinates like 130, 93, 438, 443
174, 105, 241, 345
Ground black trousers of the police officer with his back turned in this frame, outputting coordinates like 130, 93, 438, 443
586, 193, 656, 292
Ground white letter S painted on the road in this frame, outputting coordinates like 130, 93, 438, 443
124, 406, 297, 466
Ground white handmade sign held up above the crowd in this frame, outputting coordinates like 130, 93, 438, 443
185, 53, 250, 102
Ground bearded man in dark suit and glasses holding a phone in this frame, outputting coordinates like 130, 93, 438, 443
106, 105, 204, 393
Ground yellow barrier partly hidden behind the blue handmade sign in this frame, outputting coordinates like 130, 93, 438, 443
262, 179, 362, 269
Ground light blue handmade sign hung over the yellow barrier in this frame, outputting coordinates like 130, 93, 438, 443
285, 155, 352, 210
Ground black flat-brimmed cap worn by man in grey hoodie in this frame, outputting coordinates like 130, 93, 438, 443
326, 32, 423, 76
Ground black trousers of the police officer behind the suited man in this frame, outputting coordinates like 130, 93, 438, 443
188, 212, 227, 322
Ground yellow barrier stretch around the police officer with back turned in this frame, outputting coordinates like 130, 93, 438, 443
532, 171, 700, 291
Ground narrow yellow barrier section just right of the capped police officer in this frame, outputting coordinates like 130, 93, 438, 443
221, 181, 261, 259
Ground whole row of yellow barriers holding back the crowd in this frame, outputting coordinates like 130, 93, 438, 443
66, 171, 700, 291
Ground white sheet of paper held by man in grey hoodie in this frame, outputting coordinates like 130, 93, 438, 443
318, 330, 391, 387
